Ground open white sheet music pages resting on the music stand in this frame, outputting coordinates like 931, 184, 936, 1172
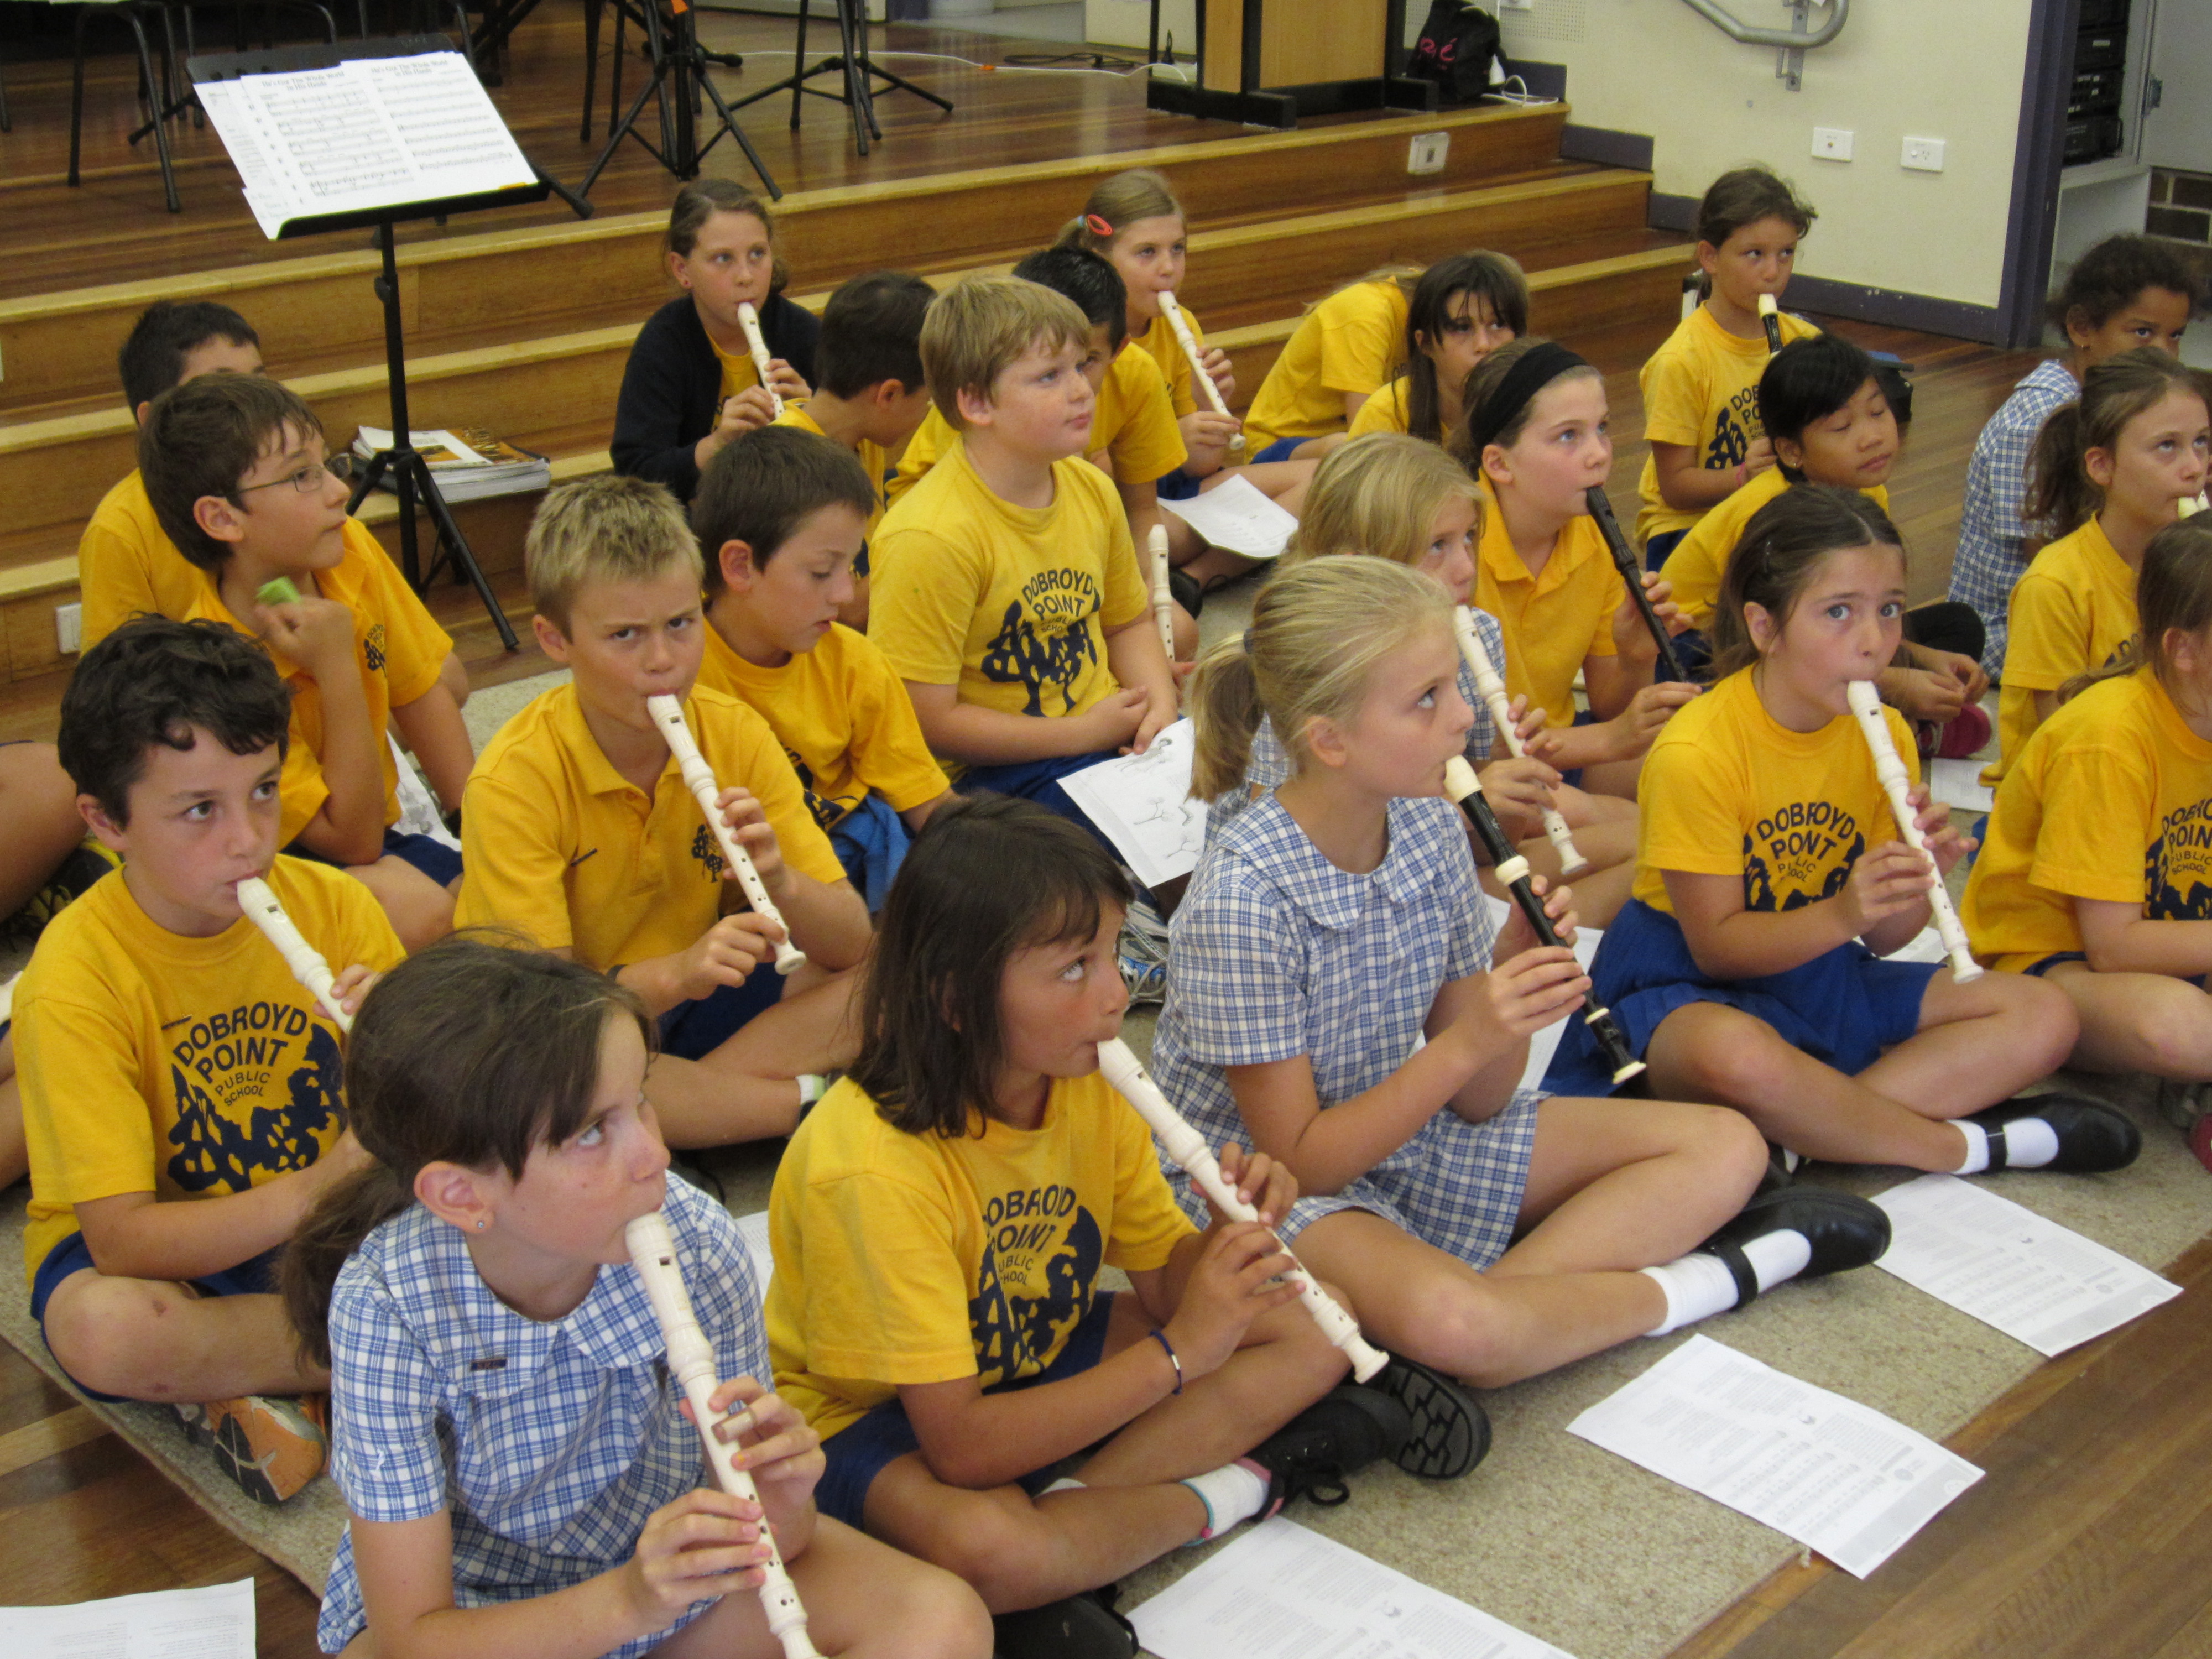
197, 51, 538, 241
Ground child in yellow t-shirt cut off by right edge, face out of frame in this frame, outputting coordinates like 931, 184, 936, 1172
1960, 513, 2212, 1166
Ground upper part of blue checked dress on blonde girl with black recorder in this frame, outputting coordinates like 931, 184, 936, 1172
1152, 794, 1498, 1157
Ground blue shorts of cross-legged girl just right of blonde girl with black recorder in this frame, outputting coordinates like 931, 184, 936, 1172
1544, 898, 1938, 1095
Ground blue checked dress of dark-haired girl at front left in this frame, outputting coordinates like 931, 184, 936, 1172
316, 1179, 770, 1659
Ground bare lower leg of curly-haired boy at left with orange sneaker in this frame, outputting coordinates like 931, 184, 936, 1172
46, 1267, 330, 1405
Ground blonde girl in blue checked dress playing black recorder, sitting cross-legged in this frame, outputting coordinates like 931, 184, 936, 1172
1152, 557, 1889, 1387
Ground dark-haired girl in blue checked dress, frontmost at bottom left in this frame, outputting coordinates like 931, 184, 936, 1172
283, 933, 991, 1659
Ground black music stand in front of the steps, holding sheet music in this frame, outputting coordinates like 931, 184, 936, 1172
186, 35, 593, 650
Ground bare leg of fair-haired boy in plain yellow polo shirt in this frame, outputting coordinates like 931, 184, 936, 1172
646, 967, 860, 1148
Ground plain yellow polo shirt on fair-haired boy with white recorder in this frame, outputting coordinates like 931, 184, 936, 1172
453, 684, 845, 971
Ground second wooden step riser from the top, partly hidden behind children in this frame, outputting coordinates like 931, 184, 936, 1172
0, 173, 1650, 546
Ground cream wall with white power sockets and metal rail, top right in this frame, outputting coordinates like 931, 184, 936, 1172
1469, 0, 2028, 305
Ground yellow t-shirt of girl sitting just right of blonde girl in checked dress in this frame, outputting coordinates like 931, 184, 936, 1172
1635, 668, 1920, 916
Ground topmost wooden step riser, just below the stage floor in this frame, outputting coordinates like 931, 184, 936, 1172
0, 104, 1566, 422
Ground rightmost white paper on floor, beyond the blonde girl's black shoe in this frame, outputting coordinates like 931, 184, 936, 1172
1876, 1175, 2181, 1356
